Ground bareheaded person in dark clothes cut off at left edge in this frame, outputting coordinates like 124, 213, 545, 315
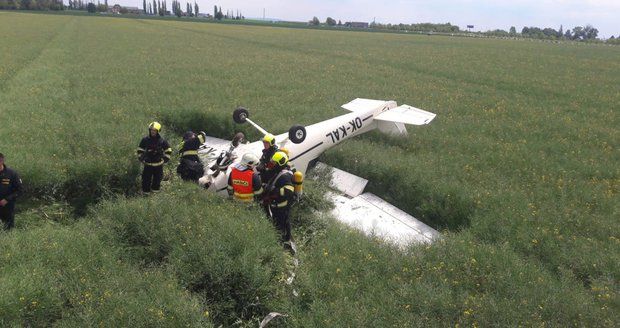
0, 153, 22, 230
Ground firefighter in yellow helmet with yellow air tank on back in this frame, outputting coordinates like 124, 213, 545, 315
263, 151, 296, 254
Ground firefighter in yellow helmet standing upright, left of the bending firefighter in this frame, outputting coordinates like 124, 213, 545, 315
136, 122, 172, 194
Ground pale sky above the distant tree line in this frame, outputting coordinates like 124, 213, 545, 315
117, 0, 620, 38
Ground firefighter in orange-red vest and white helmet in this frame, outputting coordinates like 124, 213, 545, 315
227, 153, 263, 202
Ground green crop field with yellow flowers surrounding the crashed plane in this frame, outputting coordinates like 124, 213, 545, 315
0, 11, 620, 327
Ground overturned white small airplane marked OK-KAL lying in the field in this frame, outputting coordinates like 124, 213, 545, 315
199, 98, 439, 245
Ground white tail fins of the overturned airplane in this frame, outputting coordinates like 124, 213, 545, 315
342, 98, 436, 135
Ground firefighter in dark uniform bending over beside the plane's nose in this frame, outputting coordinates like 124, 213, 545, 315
177, 131, 206, 182
